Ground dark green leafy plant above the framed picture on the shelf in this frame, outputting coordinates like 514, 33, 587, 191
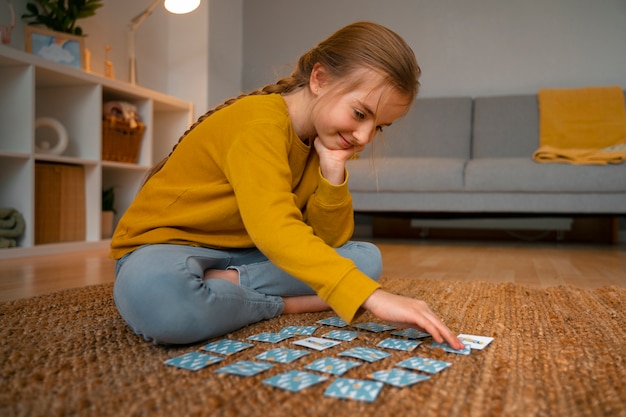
22, 0, 103, 36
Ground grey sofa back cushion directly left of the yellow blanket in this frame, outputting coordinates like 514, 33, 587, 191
472, 94, 539, 158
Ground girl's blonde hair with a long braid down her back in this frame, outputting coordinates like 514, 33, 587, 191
146, 22, 421, 181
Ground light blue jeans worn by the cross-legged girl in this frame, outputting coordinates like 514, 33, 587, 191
113, 242, 382, 344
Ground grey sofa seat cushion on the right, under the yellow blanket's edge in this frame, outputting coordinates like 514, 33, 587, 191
465, 158, 626, 194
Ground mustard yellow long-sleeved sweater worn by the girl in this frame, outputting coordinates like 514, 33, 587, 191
111, 95, 379, 322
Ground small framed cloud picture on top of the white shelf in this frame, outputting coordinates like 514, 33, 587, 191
24, 25, 85, 69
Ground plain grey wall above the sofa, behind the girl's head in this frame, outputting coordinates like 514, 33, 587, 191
243, 0, 626, 97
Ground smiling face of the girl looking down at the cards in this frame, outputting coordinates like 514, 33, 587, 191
311, 70, 409, 153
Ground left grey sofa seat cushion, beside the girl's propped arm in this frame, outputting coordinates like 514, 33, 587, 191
347, 158, 466, 192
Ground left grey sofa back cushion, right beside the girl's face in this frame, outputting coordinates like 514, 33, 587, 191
362, 97, 472, 159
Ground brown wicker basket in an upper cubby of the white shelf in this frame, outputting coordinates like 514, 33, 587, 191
102, 115, 146, 163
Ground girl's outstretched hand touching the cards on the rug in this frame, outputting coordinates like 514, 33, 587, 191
363, 289, 464, 349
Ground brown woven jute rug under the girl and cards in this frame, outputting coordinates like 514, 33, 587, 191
0, 278, 626, 417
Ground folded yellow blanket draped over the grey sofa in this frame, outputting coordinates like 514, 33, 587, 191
533, 86, 626, 165
